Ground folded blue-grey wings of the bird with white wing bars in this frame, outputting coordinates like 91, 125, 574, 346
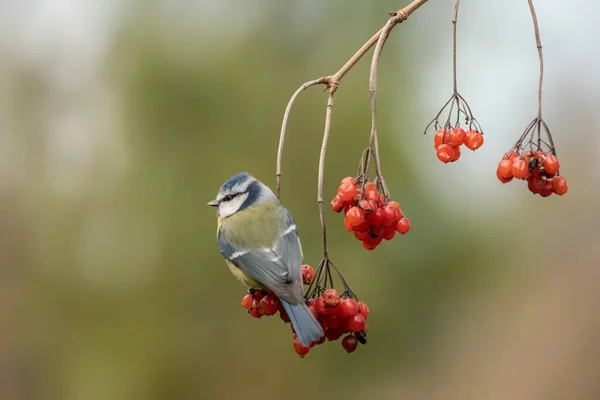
218, 213, 303, 304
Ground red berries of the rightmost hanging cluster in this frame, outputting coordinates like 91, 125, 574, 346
496, 150, 569, 197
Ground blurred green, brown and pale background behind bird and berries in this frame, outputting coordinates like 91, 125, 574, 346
0, 0, 600, 400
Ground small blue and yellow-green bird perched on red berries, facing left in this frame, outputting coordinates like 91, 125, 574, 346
208, 172, 324, 346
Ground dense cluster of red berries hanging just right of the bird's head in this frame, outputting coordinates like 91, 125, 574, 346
331, 177, 410, 250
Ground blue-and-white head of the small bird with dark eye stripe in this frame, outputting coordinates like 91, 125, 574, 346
208, 172, 275, 217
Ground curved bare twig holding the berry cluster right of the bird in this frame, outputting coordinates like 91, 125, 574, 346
369, 16, 399, 198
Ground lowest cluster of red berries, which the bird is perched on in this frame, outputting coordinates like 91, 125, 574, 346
242, 265, 369, 357
